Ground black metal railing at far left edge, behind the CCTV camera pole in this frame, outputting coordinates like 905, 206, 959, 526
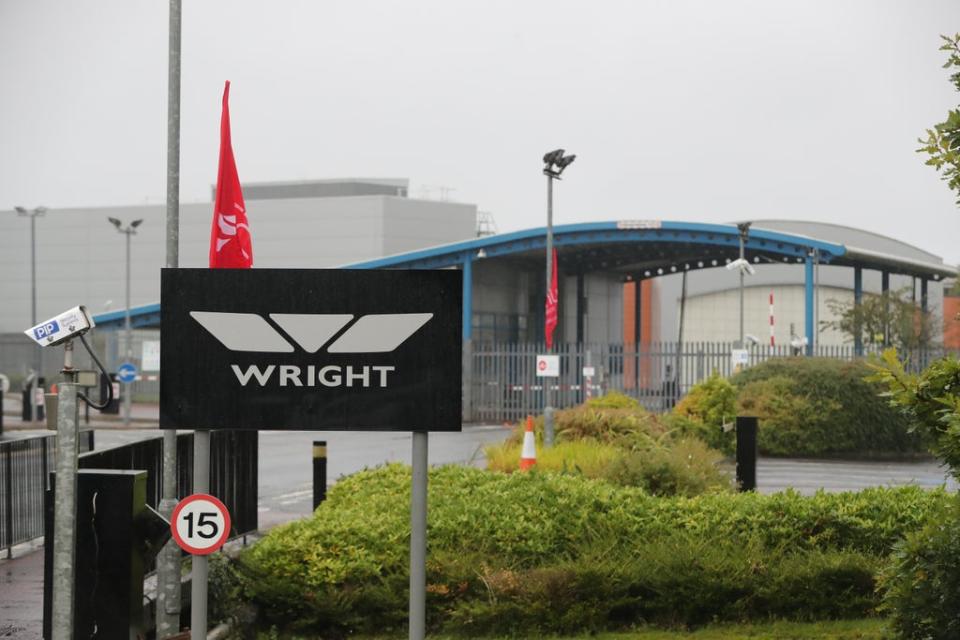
0, 431, 93, 558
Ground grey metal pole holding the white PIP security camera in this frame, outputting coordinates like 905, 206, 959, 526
51, 373, 79, 640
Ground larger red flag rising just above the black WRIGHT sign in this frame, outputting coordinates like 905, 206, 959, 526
210, 80, 253, 269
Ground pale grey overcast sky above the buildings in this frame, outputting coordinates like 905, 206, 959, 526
0, 0, 960, 264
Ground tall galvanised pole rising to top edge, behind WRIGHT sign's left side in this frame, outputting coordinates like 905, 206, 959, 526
156, 0, 181, 639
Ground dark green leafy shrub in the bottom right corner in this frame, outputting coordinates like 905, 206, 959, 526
880, 499, 960, 640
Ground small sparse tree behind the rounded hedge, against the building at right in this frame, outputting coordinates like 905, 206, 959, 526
820, 289, 937, 351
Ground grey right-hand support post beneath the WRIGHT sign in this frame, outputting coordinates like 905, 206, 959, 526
410, 431, 427, 640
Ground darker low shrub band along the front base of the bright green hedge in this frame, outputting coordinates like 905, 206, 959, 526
433, 537, 877, 637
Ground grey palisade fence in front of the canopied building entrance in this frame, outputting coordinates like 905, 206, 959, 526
465, 342, 944, 422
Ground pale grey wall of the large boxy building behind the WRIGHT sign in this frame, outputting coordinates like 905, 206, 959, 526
0, 196, 476, 333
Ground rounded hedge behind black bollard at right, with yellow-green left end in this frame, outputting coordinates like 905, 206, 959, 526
674, 358, 927, 457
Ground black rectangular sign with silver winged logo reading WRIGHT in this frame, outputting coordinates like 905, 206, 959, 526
160, 269, 463, 431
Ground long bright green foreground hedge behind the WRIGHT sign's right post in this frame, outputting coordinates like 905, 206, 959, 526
233, 465, 946, 635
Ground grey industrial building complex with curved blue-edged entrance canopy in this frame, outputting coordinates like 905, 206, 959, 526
0, 179, 956, 420
